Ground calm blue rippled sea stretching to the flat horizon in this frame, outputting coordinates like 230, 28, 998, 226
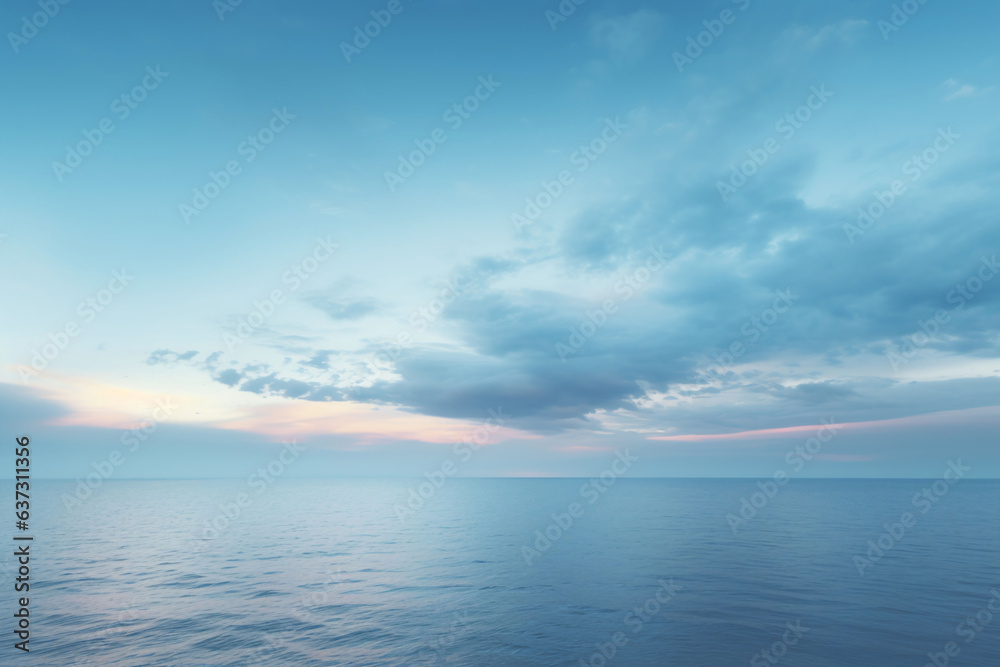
0, 478, 1000, 667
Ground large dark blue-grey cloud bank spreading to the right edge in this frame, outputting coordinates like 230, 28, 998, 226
172, 140, 1000, 433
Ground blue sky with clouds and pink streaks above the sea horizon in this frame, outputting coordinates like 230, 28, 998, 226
0, 0, 1000, 479
